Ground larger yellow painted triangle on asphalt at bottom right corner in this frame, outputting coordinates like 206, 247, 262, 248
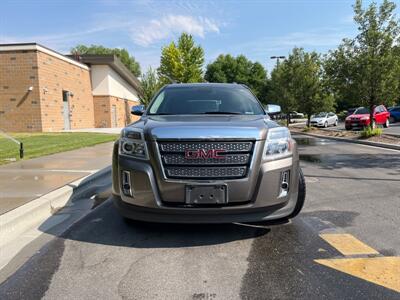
315, 257, 400, 292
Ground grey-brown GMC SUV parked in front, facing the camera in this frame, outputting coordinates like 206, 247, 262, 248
113, 83, 305, 223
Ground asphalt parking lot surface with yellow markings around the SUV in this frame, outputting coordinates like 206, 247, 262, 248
0, 136, 400, 299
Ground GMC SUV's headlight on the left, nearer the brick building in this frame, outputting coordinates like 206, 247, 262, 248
119, 128, 148, 159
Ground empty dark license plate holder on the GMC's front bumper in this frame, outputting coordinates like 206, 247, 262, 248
185, 185, 228, 205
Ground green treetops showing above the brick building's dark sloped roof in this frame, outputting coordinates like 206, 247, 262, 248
71, 45, 140, 77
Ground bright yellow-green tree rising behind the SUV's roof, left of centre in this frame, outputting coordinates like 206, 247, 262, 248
158, 33, 204, 83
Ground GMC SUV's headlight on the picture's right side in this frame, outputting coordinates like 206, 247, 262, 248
264, 127, 293, 160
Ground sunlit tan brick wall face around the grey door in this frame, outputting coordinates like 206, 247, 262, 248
38, 51, 94, 131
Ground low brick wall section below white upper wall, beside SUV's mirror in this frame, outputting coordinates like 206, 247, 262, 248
93, 96, 139, 127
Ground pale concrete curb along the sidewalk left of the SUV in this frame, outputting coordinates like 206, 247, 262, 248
0, 166, 111, 246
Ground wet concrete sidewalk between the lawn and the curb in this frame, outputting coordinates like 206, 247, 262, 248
0, 143, 113, 215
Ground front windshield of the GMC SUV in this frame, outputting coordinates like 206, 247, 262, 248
149, 86, 265, 115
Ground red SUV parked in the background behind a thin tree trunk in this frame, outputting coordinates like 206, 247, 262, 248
345, 105, 390, 130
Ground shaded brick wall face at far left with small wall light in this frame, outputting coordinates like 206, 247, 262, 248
0, 51, 42, 132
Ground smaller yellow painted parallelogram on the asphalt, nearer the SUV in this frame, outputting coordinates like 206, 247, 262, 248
320, 233, 379, 255
